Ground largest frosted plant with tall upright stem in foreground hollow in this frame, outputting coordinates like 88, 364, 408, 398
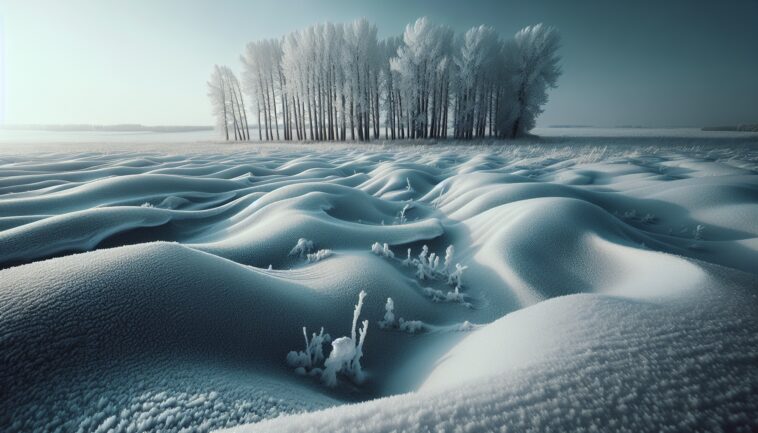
321, 290, 368, 387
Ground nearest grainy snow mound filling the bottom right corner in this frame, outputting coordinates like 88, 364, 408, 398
224, 278, 758, 433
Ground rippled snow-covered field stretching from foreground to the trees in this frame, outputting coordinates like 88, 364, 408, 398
0, 129, 758, 432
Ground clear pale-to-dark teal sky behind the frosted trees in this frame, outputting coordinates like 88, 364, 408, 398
0, 0, 758, 126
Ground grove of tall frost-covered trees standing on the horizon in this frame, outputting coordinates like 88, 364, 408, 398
208, 18, 561, 141
